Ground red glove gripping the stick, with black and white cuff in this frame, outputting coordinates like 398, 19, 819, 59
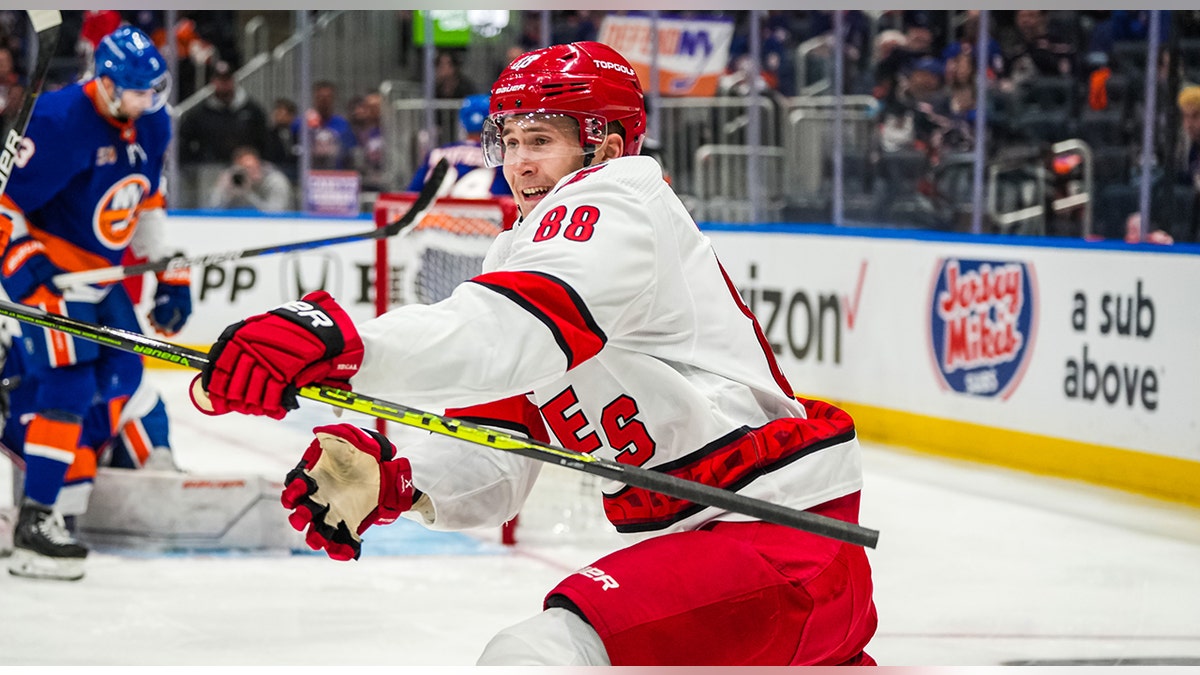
192, 291, 362, 419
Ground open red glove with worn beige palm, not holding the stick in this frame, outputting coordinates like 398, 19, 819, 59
281, 424, 419, 560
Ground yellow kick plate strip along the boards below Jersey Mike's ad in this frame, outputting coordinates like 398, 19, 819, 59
829, 401, 1200, 507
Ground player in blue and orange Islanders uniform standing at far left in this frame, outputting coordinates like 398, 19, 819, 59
0, 26, 192, 579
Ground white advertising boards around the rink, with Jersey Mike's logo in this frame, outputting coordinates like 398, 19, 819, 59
152, 213, 1200, 504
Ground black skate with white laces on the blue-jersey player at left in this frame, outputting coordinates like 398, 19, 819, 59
8, 500, 88, 581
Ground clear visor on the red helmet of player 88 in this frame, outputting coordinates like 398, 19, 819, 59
480, 110, 605, 167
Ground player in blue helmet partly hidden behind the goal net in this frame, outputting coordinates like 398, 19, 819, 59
408, 94, 512, 199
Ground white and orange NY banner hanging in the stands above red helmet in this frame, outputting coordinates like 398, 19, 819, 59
598, 14, 733, 96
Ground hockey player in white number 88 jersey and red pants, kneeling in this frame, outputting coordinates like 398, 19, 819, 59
193, 42, 876, 665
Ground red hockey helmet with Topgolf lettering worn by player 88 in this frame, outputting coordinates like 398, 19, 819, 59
484, 42, 646, 166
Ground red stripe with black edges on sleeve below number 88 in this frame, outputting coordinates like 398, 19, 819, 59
470, 271, 608, 370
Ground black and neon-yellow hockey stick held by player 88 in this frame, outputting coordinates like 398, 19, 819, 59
0, 300, 880, 549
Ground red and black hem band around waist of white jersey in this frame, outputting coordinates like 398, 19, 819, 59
604, 399, 854, 532
